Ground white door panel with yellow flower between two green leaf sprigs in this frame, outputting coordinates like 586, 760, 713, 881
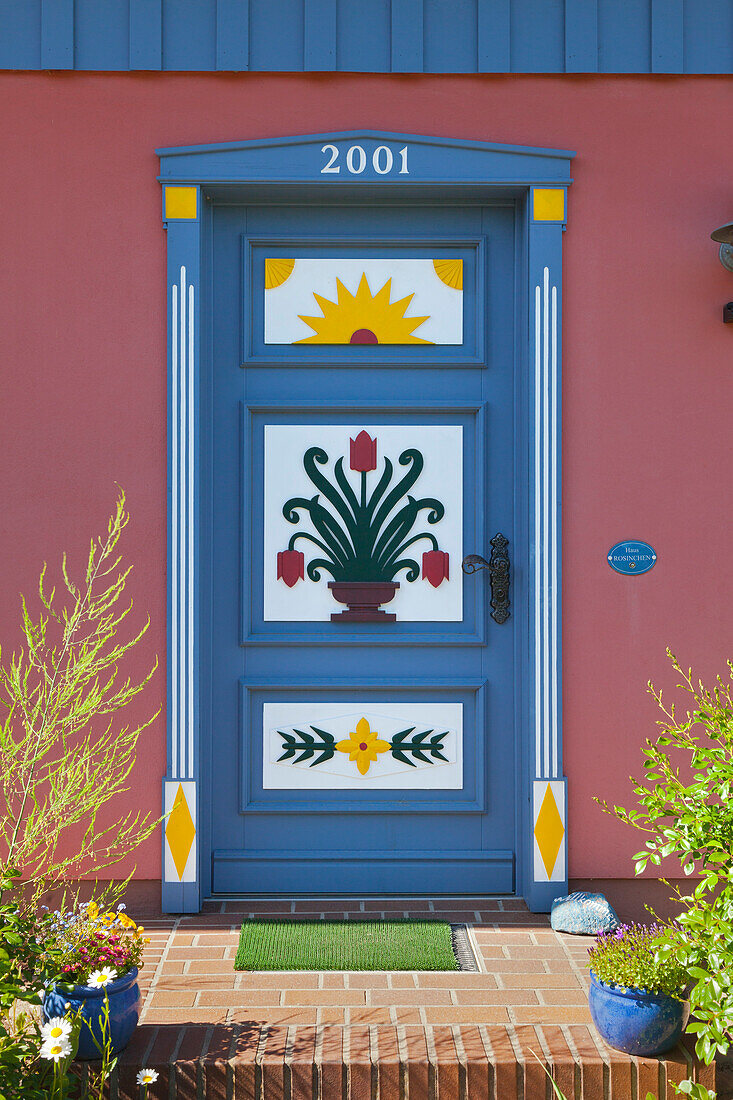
262, 701, 463, 791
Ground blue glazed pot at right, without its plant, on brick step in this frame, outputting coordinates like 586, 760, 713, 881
588, 971, 690, 1056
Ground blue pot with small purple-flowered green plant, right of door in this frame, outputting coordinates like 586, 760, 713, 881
588, 924, 690, 1056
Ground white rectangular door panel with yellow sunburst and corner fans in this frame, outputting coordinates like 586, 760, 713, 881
259, 257, 463, 344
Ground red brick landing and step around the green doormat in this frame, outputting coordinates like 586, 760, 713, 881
108, 898, 714, 1100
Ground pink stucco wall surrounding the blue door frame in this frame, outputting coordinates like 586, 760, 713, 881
0, 74, 733, 878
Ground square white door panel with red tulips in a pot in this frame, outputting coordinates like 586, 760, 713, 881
264, 424, 463, 628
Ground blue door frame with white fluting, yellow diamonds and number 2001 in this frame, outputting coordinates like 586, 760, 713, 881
156, 130, 575, 913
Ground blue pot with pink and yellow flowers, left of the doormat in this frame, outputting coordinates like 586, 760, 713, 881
43, 902, 149, 1059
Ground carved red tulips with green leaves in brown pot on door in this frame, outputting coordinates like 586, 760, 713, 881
277, 430, 449, 623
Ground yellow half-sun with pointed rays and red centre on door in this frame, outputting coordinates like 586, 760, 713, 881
296, 273, 433, 344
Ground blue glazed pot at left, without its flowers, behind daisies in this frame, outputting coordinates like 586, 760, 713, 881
43, 967, 141, 1062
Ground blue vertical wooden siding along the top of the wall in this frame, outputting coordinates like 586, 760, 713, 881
0, 0, 733, 74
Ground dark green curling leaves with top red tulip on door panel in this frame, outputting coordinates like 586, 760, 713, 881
283, 431, 445, 582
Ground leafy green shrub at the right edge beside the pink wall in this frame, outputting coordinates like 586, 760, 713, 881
599, 650, 733, 1063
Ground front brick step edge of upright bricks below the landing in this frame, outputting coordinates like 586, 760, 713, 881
98, 1024, 715, 1100
